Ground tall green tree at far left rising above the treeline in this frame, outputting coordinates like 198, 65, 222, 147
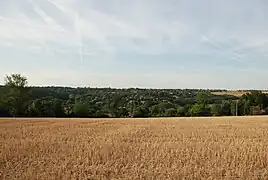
5, 74, 30, 116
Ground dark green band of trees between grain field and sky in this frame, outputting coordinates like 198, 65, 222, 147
0, 74, 268, 118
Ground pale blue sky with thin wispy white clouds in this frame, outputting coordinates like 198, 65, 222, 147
0, 0, 268, 89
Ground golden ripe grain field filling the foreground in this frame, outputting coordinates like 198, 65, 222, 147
0, 117, 268, 180
